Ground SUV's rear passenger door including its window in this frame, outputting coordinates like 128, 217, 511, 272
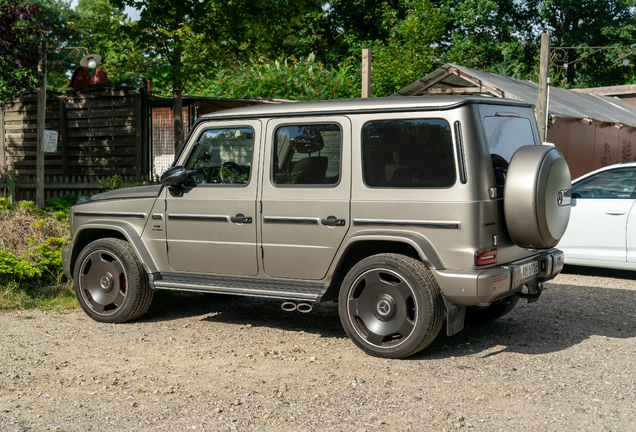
261, 117, 351, 280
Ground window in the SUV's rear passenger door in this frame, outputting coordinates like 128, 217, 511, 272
272, 124, 342, 185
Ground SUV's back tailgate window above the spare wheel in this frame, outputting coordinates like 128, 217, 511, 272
484, 117, 535, 163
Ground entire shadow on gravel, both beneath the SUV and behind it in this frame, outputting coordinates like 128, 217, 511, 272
142, 266, 636, 360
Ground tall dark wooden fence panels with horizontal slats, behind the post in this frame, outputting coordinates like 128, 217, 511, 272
0, 87, 149, 177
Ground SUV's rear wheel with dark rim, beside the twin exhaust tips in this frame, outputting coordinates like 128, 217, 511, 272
338, 254, 444, 358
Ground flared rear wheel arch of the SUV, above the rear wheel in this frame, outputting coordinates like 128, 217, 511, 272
316, 231, 445, 303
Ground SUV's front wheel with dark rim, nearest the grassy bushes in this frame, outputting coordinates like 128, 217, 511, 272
73, 238, 154, 323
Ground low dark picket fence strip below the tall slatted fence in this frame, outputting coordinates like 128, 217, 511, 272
0, 175, 150, 203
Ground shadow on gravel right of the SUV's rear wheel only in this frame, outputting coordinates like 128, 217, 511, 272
409, 266, 636, 360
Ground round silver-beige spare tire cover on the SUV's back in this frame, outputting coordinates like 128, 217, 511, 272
504, 145, 572, 249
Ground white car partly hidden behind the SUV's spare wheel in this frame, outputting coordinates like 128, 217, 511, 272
559, 162, 636, 270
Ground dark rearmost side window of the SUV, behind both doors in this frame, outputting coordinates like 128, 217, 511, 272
362, 119, 456, 188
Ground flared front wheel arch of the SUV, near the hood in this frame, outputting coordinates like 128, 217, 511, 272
70, 222, 158, 275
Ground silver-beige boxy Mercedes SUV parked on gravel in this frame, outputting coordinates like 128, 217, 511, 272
63, 97, 571, 358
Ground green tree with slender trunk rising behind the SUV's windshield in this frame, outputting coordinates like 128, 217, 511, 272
114, 0, 312, 154
